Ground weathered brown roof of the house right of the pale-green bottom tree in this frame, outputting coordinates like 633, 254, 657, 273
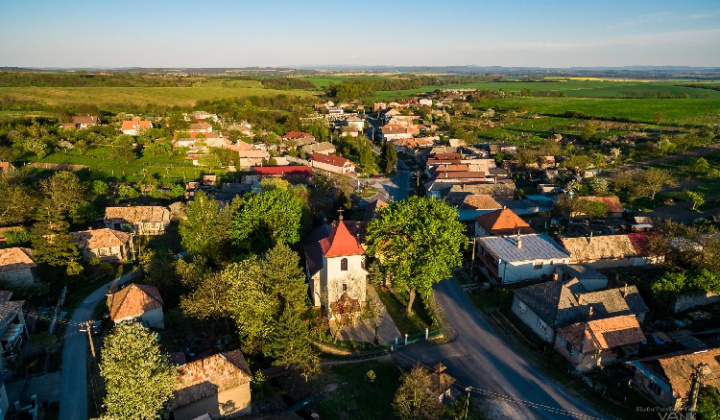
174, 350, 252, 408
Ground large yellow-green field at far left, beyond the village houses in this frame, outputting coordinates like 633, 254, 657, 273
0, 79, 317, 107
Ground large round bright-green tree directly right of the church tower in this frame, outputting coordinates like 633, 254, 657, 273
367, 196, 467, 315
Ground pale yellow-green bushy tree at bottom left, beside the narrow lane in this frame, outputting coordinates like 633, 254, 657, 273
100, 323, 176, 420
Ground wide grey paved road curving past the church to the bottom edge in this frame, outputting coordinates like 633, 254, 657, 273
398, 279, 604, 420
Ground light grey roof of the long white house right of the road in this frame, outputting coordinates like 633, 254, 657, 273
478, 234, 570, 262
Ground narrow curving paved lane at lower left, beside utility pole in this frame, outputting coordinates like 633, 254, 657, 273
60, 271, 140, 420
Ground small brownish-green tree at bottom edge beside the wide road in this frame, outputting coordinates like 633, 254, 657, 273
393, 366, 443, 420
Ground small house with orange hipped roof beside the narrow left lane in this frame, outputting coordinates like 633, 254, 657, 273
107, 283, 165, 329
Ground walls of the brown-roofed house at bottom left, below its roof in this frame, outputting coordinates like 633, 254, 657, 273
173, 383, 252, 420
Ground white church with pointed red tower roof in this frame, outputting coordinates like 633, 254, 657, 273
304, 217, 367, 320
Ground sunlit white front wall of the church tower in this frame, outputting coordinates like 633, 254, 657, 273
322, 255, 367, 308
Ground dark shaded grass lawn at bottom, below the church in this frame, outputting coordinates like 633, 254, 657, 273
314, 361, 399, 420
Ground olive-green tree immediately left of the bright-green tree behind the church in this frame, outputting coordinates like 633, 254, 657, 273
180, 191, 241, 263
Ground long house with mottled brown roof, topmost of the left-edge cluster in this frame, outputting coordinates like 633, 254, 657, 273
103, 206, 170, 235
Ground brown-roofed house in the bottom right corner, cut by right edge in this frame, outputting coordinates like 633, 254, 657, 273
627, 348, 720, 410
